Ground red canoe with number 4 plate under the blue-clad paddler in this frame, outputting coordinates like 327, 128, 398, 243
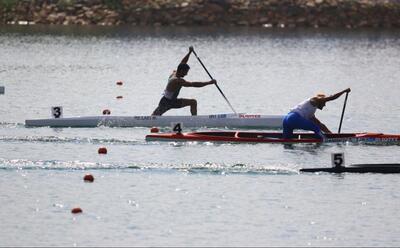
146, 131, 400, 145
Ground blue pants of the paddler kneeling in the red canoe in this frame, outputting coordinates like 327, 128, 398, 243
283, 112, 323, 139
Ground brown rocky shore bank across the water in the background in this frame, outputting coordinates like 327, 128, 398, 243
0, 0, 400, 28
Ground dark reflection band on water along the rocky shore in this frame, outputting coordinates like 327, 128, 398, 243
0, 25, 400, 41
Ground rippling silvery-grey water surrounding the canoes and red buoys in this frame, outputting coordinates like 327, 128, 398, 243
0, 26, 400, 246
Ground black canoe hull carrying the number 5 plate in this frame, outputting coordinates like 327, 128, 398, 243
300, 164, 400, 173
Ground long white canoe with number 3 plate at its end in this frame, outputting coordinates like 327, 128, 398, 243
25, 114, 284, 128
